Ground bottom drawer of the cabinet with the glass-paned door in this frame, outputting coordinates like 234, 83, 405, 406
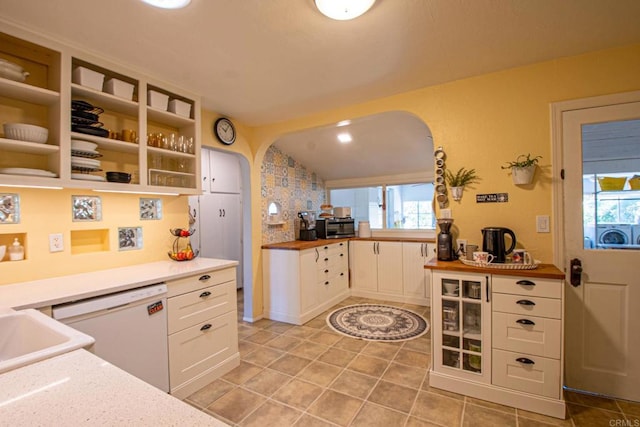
491, 349, 560, 399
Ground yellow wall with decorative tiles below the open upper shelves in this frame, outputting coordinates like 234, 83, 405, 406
0, 187, 189, 285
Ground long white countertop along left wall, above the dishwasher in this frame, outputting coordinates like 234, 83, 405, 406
0, 258, 238, 310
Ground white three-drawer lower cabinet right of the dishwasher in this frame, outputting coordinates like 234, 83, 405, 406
167, 267, 240, 399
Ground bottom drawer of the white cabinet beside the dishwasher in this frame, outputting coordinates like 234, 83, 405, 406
169, 311, 238, 389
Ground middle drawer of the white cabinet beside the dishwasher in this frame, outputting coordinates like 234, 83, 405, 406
167, 282, 237, 334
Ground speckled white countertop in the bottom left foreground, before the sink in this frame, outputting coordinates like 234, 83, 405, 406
0, 350, 228, 427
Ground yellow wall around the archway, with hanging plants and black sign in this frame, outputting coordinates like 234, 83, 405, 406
245, 45, 640, 315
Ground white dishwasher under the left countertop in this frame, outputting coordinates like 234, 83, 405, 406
53, 283, 169, 392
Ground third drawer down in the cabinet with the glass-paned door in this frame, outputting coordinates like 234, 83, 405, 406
492, 312, 562, 359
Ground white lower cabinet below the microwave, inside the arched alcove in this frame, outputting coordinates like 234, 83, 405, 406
262, 241, 349, 325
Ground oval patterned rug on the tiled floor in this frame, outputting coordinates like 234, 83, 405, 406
327, 304, 429, 341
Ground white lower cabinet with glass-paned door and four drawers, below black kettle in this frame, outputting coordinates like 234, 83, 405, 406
429, 268, 566, 418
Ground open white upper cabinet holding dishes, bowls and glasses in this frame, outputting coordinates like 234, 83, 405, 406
0, 26, 201, 194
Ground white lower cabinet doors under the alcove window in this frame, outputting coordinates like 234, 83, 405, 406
349, 240, 435, 305
